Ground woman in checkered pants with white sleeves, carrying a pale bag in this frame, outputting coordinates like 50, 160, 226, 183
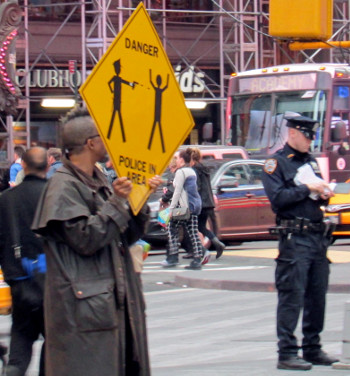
161, 149, 203, 270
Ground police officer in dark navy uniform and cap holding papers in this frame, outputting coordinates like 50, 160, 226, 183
263, 116, 338, 370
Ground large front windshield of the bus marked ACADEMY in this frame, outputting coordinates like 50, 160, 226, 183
231, 90, 327, 154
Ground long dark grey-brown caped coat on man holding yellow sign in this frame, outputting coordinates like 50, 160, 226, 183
33, 162, 150, 376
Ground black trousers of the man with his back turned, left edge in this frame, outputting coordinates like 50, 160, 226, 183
5, 282, 45, 376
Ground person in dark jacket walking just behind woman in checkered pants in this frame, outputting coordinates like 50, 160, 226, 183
191, 148, 225, 259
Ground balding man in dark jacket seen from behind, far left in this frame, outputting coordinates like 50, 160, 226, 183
0, 147, 47, 376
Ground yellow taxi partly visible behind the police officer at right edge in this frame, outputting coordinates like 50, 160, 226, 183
325, 183, 350, 240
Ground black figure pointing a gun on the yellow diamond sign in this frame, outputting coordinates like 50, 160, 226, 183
107, 59, 137, 142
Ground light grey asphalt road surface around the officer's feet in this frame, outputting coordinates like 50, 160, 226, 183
0, 241, 350, 376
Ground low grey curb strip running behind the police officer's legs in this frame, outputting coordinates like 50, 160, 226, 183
174, 275, 350, 294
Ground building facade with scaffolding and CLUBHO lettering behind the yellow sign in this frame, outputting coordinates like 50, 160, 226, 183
0, 0, 350, 165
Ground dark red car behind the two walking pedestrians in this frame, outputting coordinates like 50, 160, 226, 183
144, 159, 275, 244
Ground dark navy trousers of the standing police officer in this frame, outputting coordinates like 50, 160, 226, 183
275, 233, 329, 360
